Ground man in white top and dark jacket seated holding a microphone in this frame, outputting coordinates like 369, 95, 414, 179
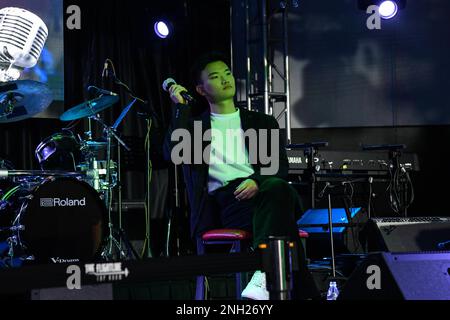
165, 53, 317, 300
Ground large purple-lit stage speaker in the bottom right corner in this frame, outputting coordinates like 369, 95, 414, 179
339, 252, 450, 300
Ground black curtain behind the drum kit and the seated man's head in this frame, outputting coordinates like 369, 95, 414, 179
0, 0, 230, 199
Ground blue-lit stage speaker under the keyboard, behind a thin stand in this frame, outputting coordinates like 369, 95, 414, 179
297, 208, 367, 258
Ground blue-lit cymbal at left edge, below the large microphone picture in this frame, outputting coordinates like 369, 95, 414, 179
0, 80, 53, 123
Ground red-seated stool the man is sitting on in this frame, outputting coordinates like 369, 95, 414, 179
195, 229, 252, 300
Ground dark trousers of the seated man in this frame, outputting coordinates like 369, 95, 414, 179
200, 177, 319, 299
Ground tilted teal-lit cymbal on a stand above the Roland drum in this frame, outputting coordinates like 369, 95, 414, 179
59, 96, 119, 121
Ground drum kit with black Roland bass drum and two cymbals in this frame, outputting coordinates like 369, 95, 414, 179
0, 80, 139, 266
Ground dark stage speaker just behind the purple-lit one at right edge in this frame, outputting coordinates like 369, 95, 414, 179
367, 217, 450, 252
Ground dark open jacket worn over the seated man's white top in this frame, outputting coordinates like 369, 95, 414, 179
164, 104, 288, 236
